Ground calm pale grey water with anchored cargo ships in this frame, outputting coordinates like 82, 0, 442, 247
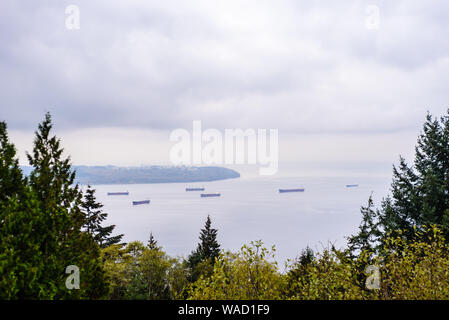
94, 177, 391, 262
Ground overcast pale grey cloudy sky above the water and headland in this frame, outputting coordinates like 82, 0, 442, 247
0, 0, 449, 175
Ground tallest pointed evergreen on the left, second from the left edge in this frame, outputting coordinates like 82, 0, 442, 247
27, 113, 107, 299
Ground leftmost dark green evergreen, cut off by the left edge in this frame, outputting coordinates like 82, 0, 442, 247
0, 122, 44, 299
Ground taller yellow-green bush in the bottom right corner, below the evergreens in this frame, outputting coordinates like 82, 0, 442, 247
381, 225, 449, 300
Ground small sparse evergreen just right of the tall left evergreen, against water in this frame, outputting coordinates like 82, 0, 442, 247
81, 185, 123, 248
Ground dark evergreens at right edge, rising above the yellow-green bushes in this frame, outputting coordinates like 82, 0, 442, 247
352, 109, 449, 249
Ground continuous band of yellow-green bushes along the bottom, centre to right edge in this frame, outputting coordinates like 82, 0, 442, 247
188, 226, 449, 300
